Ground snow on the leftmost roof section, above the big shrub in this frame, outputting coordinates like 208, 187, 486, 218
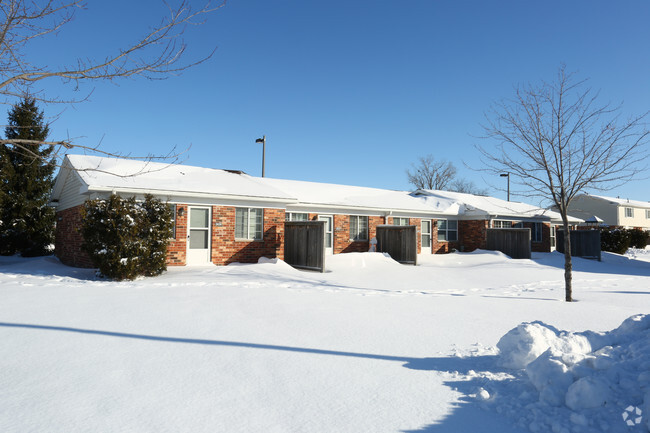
60, 155, 292, 201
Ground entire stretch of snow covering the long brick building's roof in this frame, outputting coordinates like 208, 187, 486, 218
59, 155, 582, 221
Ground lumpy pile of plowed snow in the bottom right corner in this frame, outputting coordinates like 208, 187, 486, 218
492, 314, 650, 433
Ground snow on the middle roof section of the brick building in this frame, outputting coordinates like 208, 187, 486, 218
258, 177, 458, 215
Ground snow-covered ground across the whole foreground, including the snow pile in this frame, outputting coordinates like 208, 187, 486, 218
0, 251, 650, 433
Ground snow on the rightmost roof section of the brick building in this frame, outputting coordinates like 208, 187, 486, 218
416, 190, 581, 221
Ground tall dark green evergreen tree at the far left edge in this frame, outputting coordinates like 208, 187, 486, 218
0, 97, 55, 257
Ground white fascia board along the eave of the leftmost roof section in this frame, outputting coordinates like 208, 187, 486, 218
80, 186, 296, 208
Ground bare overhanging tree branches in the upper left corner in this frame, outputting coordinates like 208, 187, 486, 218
0, 0, 225, 168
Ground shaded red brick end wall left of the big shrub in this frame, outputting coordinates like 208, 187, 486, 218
54, 205, 93, 268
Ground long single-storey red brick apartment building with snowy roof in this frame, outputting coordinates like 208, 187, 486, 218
51, 155, 576, 267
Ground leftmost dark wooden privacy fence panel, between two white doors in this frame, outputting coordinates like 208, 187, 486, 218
284, 221, 325, 272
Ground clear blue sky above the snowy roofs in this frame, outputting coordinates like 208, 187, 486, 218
20, 0, 650, 201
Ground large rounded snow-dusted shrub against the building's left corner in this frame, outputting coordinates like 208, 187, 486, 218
81, 194, 172, 280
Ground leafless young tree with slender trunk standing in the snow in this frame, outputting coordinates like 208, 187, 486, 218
478, 66, 649, 302
